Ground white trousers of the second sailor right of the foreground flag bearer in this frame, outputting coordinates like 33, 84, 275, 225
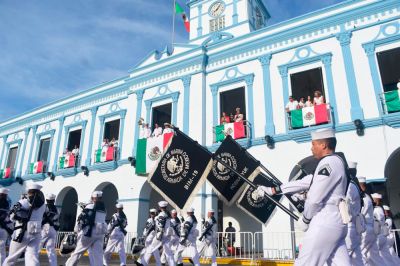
361, 224, 385, 266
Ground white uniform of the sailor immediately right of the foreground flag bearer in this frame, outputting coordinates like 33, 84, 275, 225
346, 182, 365, 266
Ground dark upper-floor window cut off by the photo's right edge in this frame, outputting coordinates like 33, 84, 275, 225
376, 47, 400, 92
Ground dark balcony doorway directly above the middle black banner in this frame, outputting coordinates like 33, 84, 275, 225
220, 87, 246, 120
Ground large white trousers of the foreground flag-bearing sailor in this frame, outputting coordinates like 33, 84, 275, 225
295, 208, 350, 266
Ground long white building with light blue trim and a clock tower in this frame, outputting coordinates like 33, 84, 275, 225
0, 0, 400, 244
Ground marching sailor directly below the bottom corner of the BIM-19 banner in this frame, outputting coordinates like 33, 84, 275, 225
175, 208, 200, 266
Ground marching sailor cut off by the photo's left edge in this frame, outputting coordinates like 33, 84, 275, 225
0, 187, 13, 265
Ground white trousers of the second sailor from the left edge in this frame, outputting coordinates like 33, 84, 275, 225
3, 232, 41, 266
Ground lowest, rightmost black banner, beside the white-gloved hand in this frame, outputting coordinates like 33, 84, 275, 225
237, 173, 282, 224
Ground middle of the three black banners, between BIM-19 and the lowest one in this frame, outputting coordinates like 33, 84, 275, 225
207, 135, 260, 205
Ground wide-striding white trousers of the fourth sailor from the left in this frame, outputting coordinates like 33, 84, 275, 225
65, 232, 104, 266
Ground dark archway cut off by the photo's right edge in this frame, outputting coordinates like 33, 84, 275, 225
385, 148, 400, 228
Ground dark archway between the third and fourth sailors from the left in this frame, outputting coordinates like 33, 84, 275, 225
56, 187, 78, 231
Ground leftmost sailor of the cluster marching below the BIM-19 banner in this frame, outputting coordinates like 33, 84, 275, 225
135, 209, 161, 266
